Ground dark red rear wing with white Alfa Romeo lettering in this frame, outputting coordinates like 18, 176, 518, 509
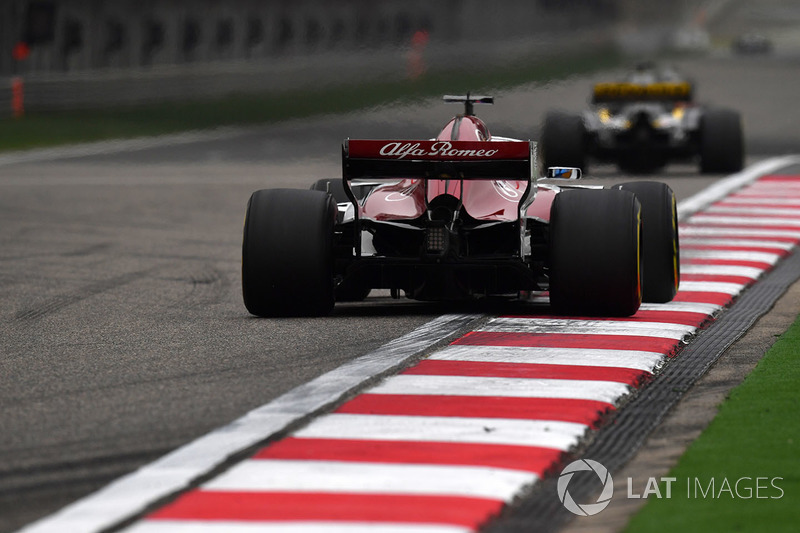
342, 139, 536, 181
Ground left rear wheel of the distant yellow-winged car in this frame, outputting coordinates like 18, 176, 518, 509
540, 111, 586, 171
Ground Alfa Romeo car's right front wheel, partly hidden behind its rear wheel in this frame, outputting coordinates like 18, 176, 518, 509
616, 181, 680, 303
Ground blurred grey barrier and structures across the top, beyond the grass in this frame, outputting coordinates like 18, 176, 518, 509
0, 0, 800, 112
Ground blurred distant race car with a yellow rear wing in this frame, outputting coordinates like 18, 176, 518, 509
540, 64, 744, 173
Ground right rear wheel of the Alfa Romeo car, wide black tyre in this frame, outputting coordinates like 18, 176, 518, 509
549, 189, 642, 316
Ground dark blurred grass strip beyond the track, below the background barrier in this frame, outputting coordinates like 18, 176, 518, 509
0, 49, 621, 151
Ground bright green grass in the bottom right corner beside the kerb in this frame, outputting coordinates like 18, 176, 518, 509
626, 317, 800, 533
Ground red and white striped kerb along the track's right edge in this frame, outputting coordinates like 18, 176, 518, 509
122, 171, 800, 533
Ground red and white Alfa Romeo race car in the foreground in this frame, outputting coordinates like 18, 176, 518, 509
242, 95, 679, 316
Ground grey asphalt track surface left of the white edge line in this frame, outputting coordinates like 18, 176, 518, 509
0, 58, 800, 531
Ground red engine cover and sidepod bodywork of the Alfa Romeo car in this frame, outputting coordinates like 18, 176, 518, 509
361, 115, 555, 222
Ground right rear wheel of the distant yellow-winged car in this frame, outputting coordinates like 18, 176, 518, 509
700, 109, 744, 174
